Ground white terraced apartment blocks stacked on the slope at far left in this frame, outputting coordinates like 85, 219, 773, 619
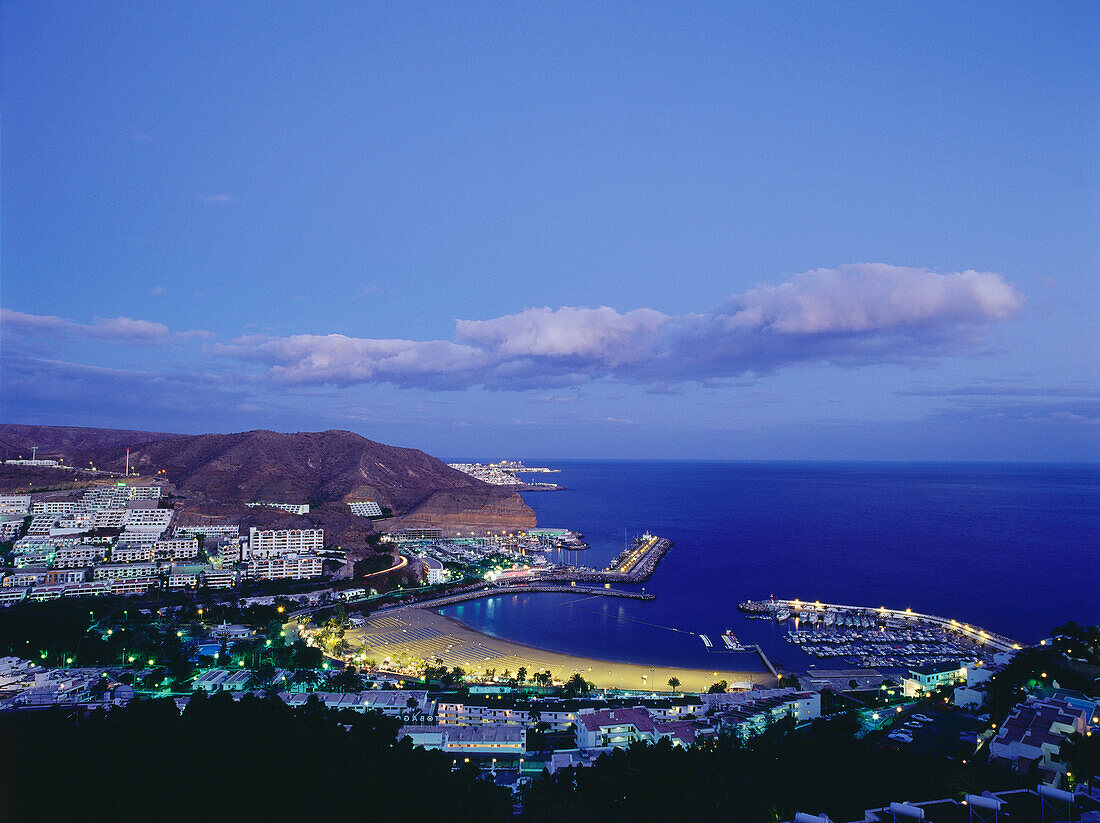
0, 483, 334, 606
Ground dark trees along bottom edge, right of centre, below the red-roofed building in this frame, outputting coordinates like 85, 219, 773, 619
524, 718, 1019, 823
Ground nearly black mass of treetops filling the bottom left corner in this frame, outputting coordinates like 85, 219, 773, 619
0, 694, 510, 823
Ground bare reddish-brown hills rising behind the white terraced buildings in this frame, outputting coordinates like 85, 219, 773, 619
0, 425, 535, 528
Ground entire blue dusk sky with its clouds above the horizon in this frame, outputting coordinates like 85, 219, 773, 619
0, 0, 1100, 460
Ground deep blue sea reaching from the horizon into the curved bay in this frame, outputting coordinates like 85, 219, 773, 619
435, 460, 1100, 670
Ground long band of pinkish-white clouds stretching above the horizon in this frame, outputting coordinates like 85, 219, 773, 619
0, 264, 1023, 394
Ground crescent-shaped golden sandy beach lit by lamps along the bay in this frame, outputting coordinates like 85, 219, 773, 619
347, 606, 776, 692
